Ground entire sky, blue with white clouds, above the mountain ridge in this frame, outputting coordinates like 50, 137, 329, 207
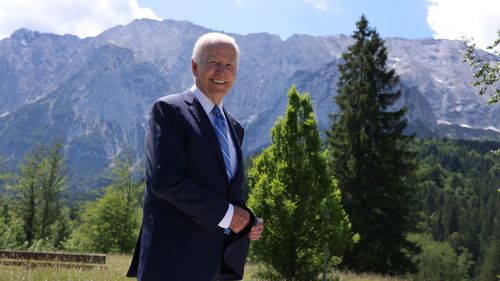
0, 0, 500, 48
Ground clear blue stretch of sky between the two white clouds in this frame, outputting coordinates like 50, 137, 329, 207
138, 0, 433, 40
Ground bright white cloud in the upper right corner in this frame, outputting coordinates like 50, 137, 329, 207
427, 0, 500, 49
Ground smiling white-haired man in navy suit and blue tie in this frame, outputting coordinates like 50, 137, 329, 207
127, 33, 264, 281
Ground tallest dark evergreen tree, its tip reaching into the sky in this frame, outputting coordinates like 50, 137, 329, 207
328, 16, 418, 274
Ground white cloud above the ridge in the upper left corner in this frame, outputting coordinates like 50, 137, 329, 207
0, 0, 160, 39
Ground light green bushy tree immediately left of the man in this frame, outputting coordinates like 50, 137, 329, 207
66, 156, 143, 253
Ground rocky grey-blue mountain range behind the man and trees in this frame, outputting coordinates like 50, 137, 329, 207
0, 20, 500, 189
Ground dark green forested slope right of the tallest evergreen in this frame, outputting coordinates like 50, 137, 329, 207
415, 140, 500, 280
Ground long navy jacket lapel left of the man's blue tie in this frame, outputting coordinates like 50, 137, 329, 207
182, 90, 226, 180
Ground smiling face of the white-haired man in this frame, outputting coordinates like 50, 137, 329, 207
191, 42, 237, 104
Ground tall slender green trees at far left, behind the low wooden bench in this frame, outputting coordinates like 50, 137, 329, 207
2, 142, 69, 249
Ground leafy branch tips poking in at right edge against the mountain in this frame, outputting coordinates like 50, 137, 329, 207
464, 30, 500, 103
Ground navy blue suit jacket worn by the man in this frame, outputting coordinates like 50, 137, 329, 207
127, 90, 254, 281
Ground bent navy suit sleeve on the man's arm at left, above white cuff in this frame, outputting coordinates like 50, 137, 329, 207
146, 101, 228, 231
